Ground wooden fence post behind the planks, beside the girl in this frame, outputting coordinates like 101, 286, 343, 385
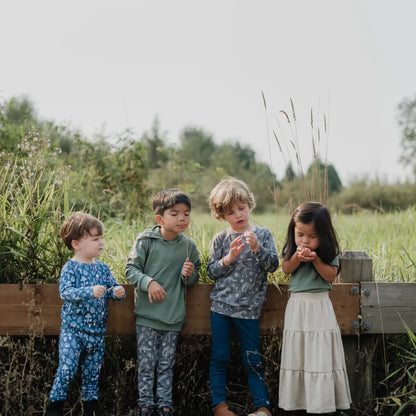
340, 251, 375, 403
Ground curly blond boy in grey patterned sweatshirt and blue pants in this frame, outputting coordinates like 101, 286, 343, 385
207, 179, 279, 416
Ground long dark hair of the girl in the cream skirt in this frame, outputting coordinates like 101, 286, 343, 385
282, 202, 340, 272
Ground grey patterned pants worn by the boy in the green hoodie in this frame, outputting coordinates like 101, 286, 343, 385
136, 325, 179, 409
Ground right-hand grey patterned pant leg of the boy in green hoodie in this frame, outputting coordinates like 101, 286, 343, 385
156, 331, 179, 410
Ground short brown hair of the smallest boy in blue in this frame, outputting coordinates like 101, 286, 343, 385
61, 212, 104, 250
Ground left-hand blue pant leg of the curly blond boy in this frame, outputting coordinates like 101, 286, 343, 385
209, 312, 232, 406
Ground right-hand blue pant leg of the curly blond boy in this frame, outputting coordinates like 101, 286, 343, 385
234, 319, 270, 409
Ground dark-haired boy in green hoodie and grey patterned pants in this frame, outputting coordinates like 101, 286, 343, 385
126, 188, 201, 416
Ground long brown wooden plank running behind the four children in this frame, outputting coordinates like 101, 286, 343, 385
0, 283, 359, 335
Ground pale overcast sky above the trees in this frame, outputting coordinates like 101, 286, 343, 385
0, 0, 416, 183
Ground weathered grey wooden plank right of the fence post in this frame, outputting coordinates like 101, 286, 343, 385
361, 282, 416, 334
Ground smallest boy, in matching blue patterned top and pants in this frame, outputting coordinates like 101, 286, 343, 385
46, 212, 125, 416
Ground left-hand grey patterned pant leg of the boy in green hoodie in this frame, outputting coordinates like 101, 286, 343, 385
136, 325, 158, 408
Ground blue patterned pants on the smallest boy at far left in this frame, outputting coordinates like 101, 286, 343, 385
49, 329, 105, 402
